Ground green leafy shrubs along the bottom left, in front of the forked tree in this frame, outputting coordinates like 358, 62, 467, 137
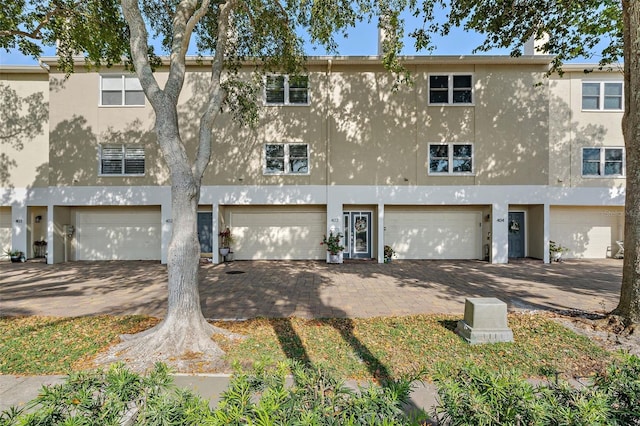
0, 363, 430, 426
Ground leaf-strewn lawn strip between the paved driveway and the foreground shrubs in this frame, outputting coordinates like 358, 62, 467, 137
0, 314, 612, 379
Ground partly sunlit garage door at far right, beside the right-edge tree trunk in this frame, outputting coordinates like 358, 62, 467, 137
549, 207, 624, 259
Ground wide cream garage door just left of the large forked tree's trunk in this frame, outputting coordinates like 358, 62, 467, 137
76, 208, 162, 260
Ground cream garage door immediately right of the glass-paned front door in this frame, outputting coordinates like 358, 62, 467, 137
384, 211, 482, 259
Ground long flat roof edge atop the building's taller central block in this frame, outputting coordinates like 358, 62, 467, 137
40, 55, 554, 66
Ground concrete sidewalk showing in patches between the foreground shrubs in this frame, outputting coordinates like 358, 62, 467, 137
0, 374, 437, 414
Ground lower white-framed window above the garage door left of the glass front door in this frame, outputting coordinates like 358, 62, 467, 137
264, 143, 309, 175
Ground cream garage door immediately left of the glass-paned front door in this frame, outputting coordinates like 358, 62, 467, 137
230, 210, 326, 260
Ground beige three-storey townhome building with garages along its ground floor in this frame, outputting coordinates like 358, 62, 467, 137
0, 50, 625, 263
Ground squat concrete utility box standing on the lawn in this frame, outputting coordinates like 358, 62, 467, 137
456, 297, 513, 345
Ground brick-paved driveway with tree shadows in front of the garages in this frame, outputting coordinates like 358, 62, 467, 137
0, 259, 622, 319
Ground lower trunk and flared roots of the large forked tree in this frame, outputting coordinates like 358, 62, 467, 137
97, 173, 237, 372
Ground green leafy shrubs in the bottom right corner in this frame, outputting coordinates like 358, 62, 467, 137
435, 355, 640, 426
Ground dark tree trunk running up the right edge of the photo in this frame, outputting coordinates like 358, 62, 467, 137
614, 0, 640, 324
